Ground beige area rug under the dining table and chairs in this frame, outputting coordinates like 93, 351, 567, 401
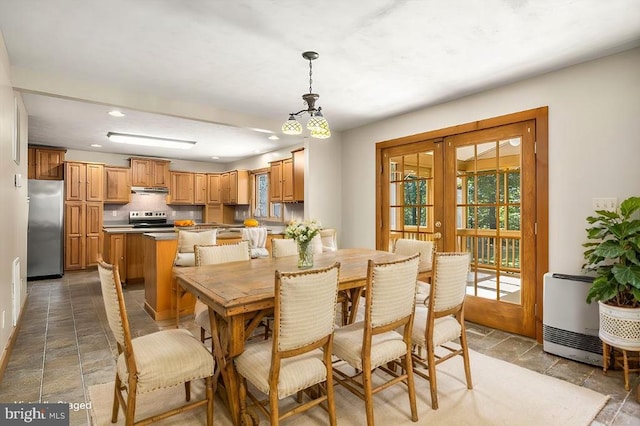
89, 351, 609, 426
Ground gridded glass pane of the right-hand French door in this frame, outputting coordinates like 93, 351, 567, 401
456, 138, 520, 304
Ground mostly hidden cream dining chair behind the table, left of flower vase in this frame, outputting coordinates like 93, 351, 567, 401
193, 241, 251, 351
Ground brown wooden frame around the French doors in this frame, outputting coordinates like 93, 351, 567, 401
376, 106, 549, 342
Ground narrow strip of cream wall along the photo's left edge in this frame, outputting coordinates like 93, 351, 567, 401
0, 34, 28, 355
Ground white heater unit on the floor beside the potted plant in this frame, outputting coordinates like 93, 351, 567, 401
542, 272, 602, 366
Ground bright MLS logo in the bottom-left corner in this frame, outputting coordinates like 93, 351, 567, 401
0, 404, 69, 426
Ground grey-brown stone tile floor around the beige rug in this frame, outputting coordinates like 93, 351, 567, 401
0, 271, 640, 426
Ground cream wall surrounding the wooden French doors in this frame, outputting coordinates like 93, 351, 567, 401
340, 48, 640, 274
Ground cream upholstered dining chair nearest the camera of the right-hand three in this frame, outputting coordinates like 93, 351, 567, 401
234, 262, 340, 425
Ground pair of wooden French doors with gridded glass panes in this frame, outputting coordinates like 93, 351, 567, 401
377, 111, 546, 337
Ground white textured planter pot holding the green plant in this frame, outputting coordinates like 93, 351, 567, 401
598, 302, 640, 351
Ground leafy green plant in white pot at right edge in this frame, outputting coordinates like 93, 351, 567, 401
583, 197, 640, 350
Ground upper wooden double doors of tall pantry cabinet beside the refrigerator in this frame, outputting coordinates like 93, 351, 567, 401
64, 161, 104, 201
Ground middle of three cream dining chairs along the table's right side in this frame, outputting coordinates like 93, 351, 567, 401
333, 254, 420, 426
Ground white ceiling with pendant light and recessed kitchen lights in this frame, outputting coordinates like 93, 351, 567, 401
0, 0, 640, 162
